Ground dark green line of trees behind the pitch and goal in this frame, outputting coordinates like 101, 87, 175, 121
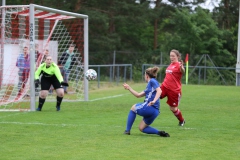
3, 0, 239, 84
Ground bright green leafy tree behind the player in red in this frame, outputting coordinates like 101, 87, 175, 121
161, 8, 232, 64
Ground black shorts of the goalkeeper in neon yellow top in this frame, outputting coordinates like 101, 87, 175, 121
41, 75, 63, 90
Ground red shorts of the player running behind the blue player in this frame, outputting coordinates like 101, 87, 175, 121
160, 86, 182, 107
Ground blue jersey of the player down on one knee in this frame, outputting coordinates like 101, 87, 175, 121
144, 78, 160, 109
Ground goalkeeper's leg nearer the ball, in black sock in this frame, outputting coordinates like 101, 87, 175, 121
52, 77, 64, 111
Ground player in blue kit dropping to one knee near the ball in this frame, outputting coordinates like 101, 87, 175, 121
123, 67, 170, 137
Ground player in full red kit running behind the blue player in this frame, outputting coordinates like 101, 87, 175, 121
160, 49, 185, 126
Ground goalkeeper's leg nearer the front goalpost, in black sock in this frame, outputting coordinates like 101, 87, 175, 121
37, 77, 51, 111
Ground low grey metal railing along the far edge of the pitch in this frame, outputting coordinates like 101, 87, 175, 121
89, 64, 236, 88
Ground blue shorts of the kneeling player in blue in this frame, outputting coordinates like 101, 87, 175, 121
135, 102, 159, 125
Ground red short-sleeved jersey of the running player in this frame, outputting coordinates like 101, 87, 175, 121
162, 62, 182, 92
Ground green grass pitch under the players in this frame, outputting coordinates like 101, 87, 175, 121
0, 83, 240, 160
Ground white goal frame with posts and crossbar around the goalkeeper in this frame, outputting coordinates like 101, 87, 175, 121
0, 4, 89, 111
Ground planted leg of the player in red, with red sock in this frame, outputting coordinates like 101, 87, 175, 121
167, 92, 185, 126
